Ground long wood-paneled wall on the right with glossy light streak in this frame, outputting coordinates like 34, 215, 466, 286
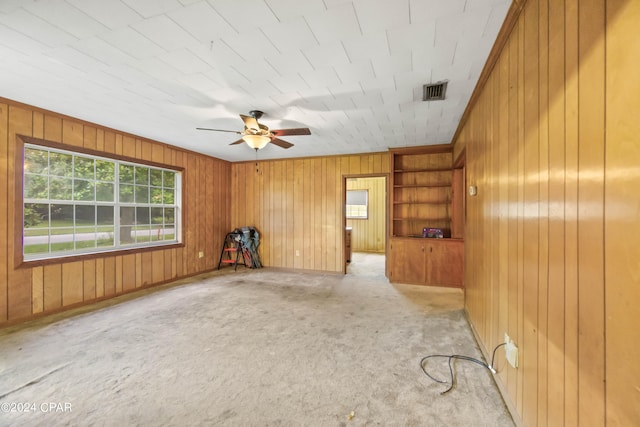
454, 0, 640, 426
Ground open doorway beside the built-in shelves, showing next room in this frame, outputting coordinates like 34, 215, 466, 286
343, 175, 388, 274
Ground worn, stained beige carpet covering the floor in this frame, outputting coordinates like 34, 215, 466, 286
0, 254, 513, 426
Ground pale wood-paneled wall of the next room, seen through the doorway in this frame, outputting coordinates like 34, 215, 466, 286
347, 177, 387, 253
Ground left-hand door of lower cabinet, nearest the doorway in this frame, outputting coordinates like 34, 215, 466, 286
389, 239, 426, 285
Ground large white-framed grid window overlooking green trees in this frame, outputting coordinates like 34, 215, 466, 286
23, 144, 181, 260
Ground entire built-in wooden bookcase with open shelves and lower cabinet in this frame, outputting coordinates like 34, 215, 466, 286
387, 145, 464, 287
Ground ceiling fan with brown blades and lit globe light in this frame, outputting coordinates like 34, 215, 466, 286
196, 110, 311, 151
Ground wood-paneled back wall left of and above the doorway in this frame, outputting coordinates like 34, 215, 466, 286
231, 153, 389, 272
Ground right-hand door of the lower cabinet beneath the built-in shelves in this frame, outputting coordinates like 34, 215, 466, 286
425, 239, 464, 287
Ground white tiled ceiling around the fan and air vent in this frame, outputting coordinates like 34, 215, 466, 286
0, 0, 511, 161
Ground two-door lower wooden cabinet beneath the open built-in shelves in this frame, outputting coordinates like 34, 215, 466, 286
389, 237, 464, 287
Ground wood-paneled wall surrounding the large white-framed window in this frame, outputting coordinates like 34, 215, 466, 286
0, 98, 231, 326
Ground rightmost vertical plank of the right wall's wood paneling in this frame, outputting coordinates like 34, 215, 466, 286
594, 0, 640, 426
